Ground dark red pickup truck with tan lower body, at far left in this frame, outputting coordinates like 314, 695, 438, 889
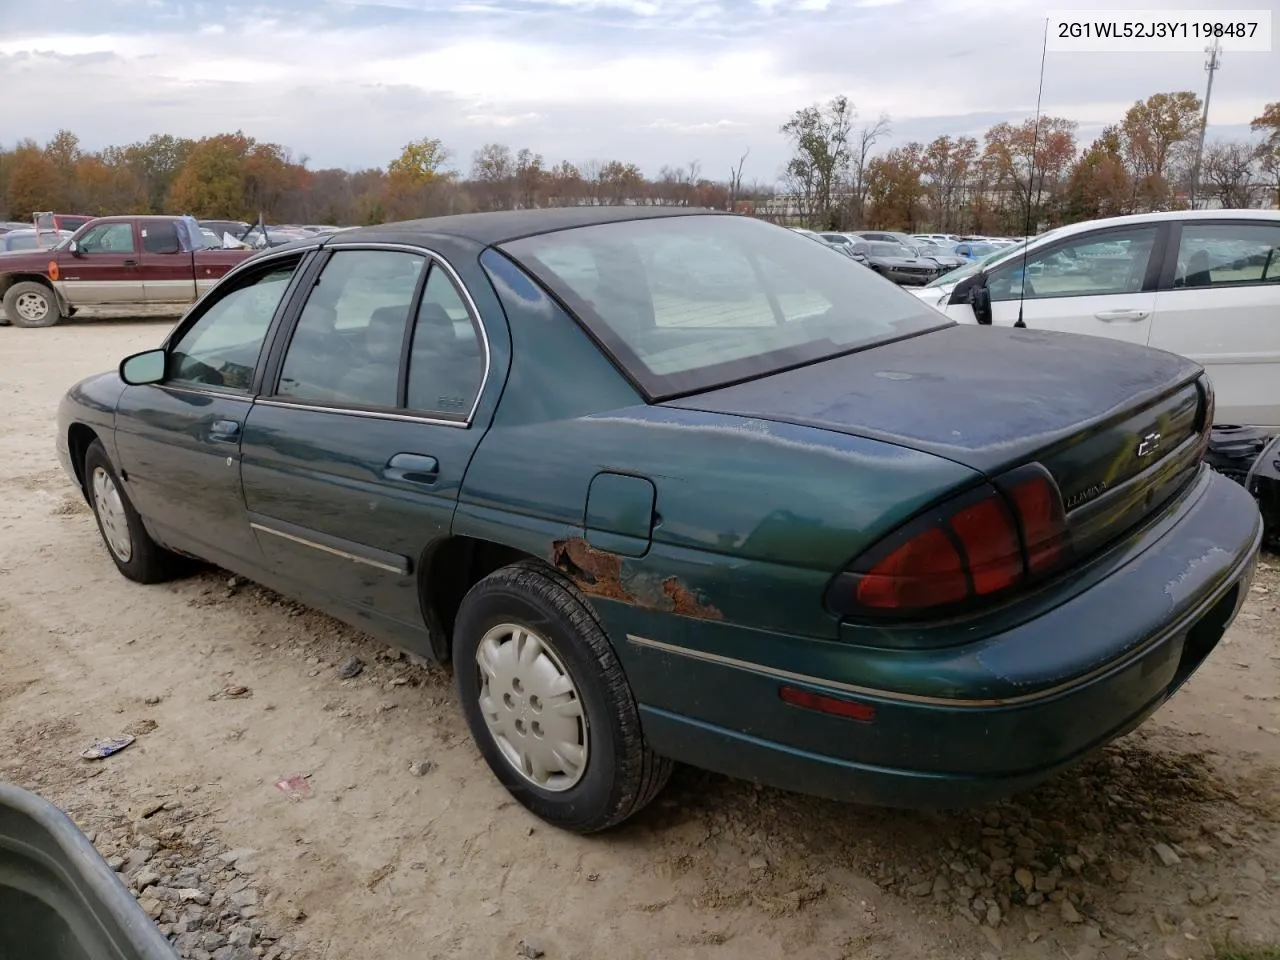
0, 216, 252, 326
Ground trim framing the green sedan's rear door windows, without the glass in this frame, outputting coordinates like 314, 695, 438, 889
256, 241, 493, 430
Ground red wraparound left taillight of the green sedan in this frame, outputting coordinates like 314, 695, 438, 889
827, 465, 1070, 618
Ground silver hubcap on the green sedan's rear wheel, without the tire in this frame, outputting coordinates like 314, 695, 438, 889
476, 623, 589, 792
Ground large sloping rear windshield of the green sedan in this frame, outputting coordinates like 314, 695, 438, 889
502, 215, 951, 401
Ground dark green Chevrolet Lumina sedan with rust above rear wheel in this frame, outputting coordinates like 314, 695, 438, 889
56, 206, 1261, 832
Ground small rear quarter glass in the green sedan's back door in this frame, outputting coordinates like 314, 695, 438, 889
407, 266, 485, 417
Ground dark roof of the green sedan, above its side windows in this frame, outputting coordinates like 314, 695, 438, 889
327, 206, 733, 246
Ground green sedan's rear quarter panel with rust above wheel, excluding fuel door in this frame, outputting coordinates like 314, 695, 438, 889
454, 255, 980, 639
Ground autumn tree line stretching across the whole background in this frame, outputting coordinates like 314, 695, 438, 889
0, 91, 1280, 234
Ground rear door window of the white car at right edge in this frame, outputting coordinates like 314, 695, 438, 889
1174, 223, 1280, 289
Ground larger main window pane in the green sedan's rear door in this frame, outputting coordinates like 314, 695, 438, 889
276, 250, 426, 407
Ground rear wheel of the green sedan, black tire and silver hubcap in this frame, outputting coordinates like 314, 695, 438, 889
453, 561, 672, 833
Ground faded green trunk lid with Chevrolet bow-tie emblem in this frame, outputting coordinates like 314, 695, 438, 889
668, 325, 1212, 563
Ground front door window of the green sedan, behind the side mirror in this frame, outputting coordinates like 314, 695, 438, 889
165, 257, 301, 394
